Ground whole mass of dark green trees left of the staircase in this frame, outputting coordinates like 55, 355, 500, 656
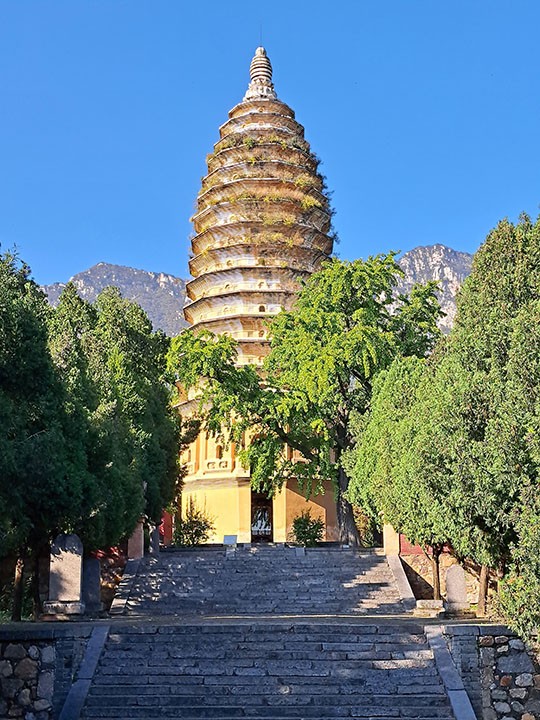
0, 254, 184, 617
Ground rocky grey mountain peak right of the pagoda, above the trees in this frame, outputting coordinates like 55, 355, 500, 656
398, 245, 473, 333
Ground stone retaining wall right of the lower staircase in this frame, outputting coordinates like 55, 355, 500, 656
444, 625, 540, 720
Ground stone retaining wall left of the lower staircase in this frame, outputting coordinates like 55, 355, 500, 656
0, 623, 91, 720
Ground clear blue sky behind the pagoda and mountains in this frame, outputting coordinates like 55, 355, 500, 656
0, 0, 540, 283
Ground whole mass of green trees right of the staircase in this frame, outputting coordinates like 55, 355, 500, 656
348, 216, 540, 631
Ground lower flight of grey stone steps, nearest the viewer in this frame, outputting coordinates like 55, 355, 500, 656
83, 620, 454, 720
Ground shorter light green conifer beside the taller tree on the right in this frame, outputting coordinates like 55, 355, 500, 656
345, 356, 448, 599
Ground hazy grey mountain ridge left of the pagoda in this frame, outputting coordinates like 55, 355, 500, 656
42, 263, 187, 335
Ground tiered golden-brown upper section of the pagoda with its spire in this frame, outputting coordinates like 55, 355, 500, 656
184, 47, 333, 364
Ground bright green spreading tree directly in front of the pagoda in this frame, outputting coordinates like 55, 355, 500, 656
171, 254, 440, 544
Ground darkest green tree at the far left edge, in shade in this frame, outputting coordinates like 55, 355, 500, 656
0, 253, 84, 620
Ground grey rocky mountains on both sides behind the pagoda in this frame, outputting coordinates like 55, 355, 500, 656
43, 245, 472, 335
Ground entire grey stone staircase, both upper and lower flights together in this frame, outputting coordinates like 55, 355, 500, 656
79, 546, 460, 720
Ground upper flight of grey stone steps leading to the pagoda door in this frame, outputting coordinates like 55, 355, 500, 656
121, 545, 403, 617
